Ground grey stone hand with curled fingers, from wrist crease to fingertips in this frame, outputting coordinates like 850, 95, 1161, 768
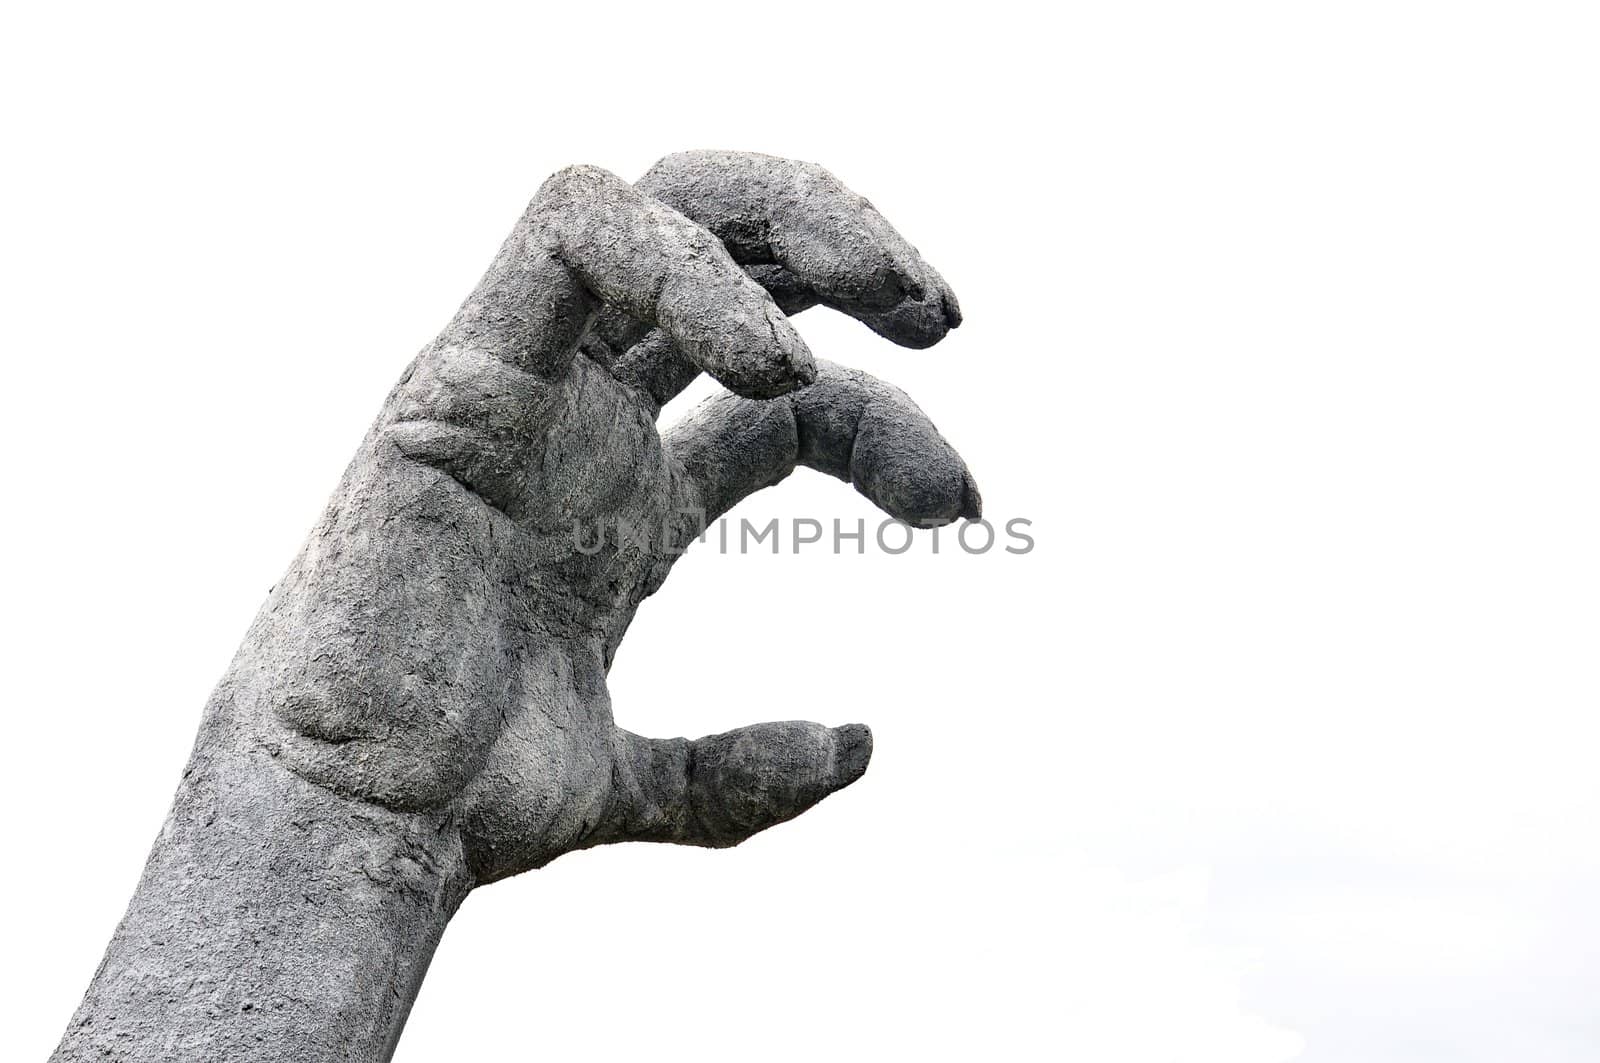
248, 152, 979, 882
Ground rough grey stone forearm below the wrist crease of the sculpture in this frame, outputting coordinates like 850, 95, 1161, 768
51, 688, 469, 1063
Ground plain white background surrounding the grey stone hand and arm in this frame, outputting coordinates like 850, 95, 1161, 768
0, 2, 1600, 1063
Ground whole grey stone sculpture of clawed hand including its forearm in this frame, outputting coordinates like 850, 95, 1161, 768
53, 152, 979, 1063
